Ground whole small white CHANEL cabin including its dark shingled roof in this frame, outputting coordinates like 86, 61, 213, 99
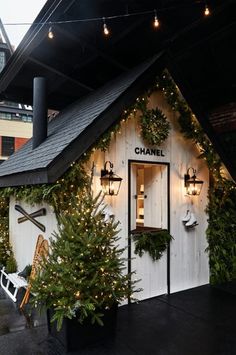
0, 56, 209, 299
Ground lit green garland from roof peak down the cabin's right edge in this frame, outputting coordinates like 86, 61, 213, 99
156, 71, 236, 284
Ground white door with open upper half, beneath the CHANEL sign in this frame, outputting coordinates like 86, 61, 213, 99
130, 163, 168, 300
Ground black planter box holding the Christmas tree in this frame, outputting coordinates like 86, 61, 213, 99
48, 306, 118, 351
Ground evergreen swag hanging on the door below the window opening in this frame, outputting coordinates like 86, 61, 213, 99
132, 229, 173, 261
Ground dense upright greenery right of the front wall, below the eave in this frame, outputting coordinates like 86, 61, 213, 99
206, 180, 236, 284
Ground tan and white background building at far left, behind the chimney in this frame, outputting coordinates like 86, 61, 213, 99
0, 20, 33, 163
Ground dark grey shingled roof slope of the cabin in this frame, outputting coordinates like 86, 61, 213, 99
0, 54, 162, 187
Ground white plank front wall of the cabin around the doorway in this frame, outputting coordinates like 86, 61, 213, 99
91, 93, 209, 299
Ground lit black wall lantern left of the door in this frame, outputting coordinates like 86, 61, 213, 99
101, 161, 122, 196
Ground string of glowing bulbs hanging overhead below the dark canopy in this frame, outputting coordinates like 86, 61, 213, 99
1, 4, 211, 39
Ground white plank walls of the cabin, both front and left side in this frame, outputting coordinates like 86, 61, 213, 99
10, 90, 209, 299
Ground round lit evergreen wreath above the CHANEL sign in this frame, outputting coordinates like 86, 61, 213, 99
140, 108, 170, 145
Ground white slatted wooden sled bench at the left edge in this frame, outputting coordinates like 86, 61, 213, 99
1, 268, 28, 302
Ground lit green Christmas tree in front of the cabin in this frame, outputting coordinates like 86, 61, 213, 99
32, 188, 138, 329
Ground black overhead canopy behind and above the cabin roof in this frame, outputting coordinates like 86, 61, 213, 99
0, 0, 236, 178
